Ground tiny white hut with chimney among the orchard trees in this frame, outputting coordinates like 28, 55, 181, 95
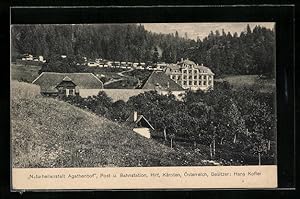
126, 111, 154, 138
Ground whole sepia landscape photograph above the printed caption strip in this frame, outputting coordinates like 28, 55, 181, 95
11, 22, 277, 168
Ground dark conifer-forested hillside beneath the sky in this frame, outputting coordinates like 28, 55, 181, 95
11, 24, 275, 76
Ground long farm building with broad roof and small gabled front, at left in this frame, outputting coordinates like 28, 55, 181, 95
32, 72, 103, 97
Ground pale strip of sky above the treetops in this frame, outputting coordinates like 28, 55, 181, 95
142, 22, 275, 40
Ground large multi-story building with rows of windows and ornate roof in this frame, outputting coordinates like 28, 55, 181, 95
165, 59, 214, 90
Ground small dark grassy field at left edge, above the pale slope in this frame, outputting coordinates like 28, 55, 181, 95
11, 64, 41, 82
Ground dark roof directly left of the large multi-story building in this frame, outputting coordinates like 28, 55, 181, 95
142, 71, 183, 91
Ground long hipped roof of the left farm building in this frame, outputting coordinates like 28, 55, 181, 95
32, 72, 103, 92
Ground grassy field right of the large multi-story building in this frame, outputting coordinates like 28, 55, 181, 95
215, 75, 276, 92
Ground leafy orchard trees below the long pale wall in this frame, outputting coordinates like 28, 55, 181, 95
59, 83, 276, 164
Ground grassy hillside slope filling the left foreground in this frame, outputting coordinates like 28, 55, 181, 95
11, 82, 209, 167
